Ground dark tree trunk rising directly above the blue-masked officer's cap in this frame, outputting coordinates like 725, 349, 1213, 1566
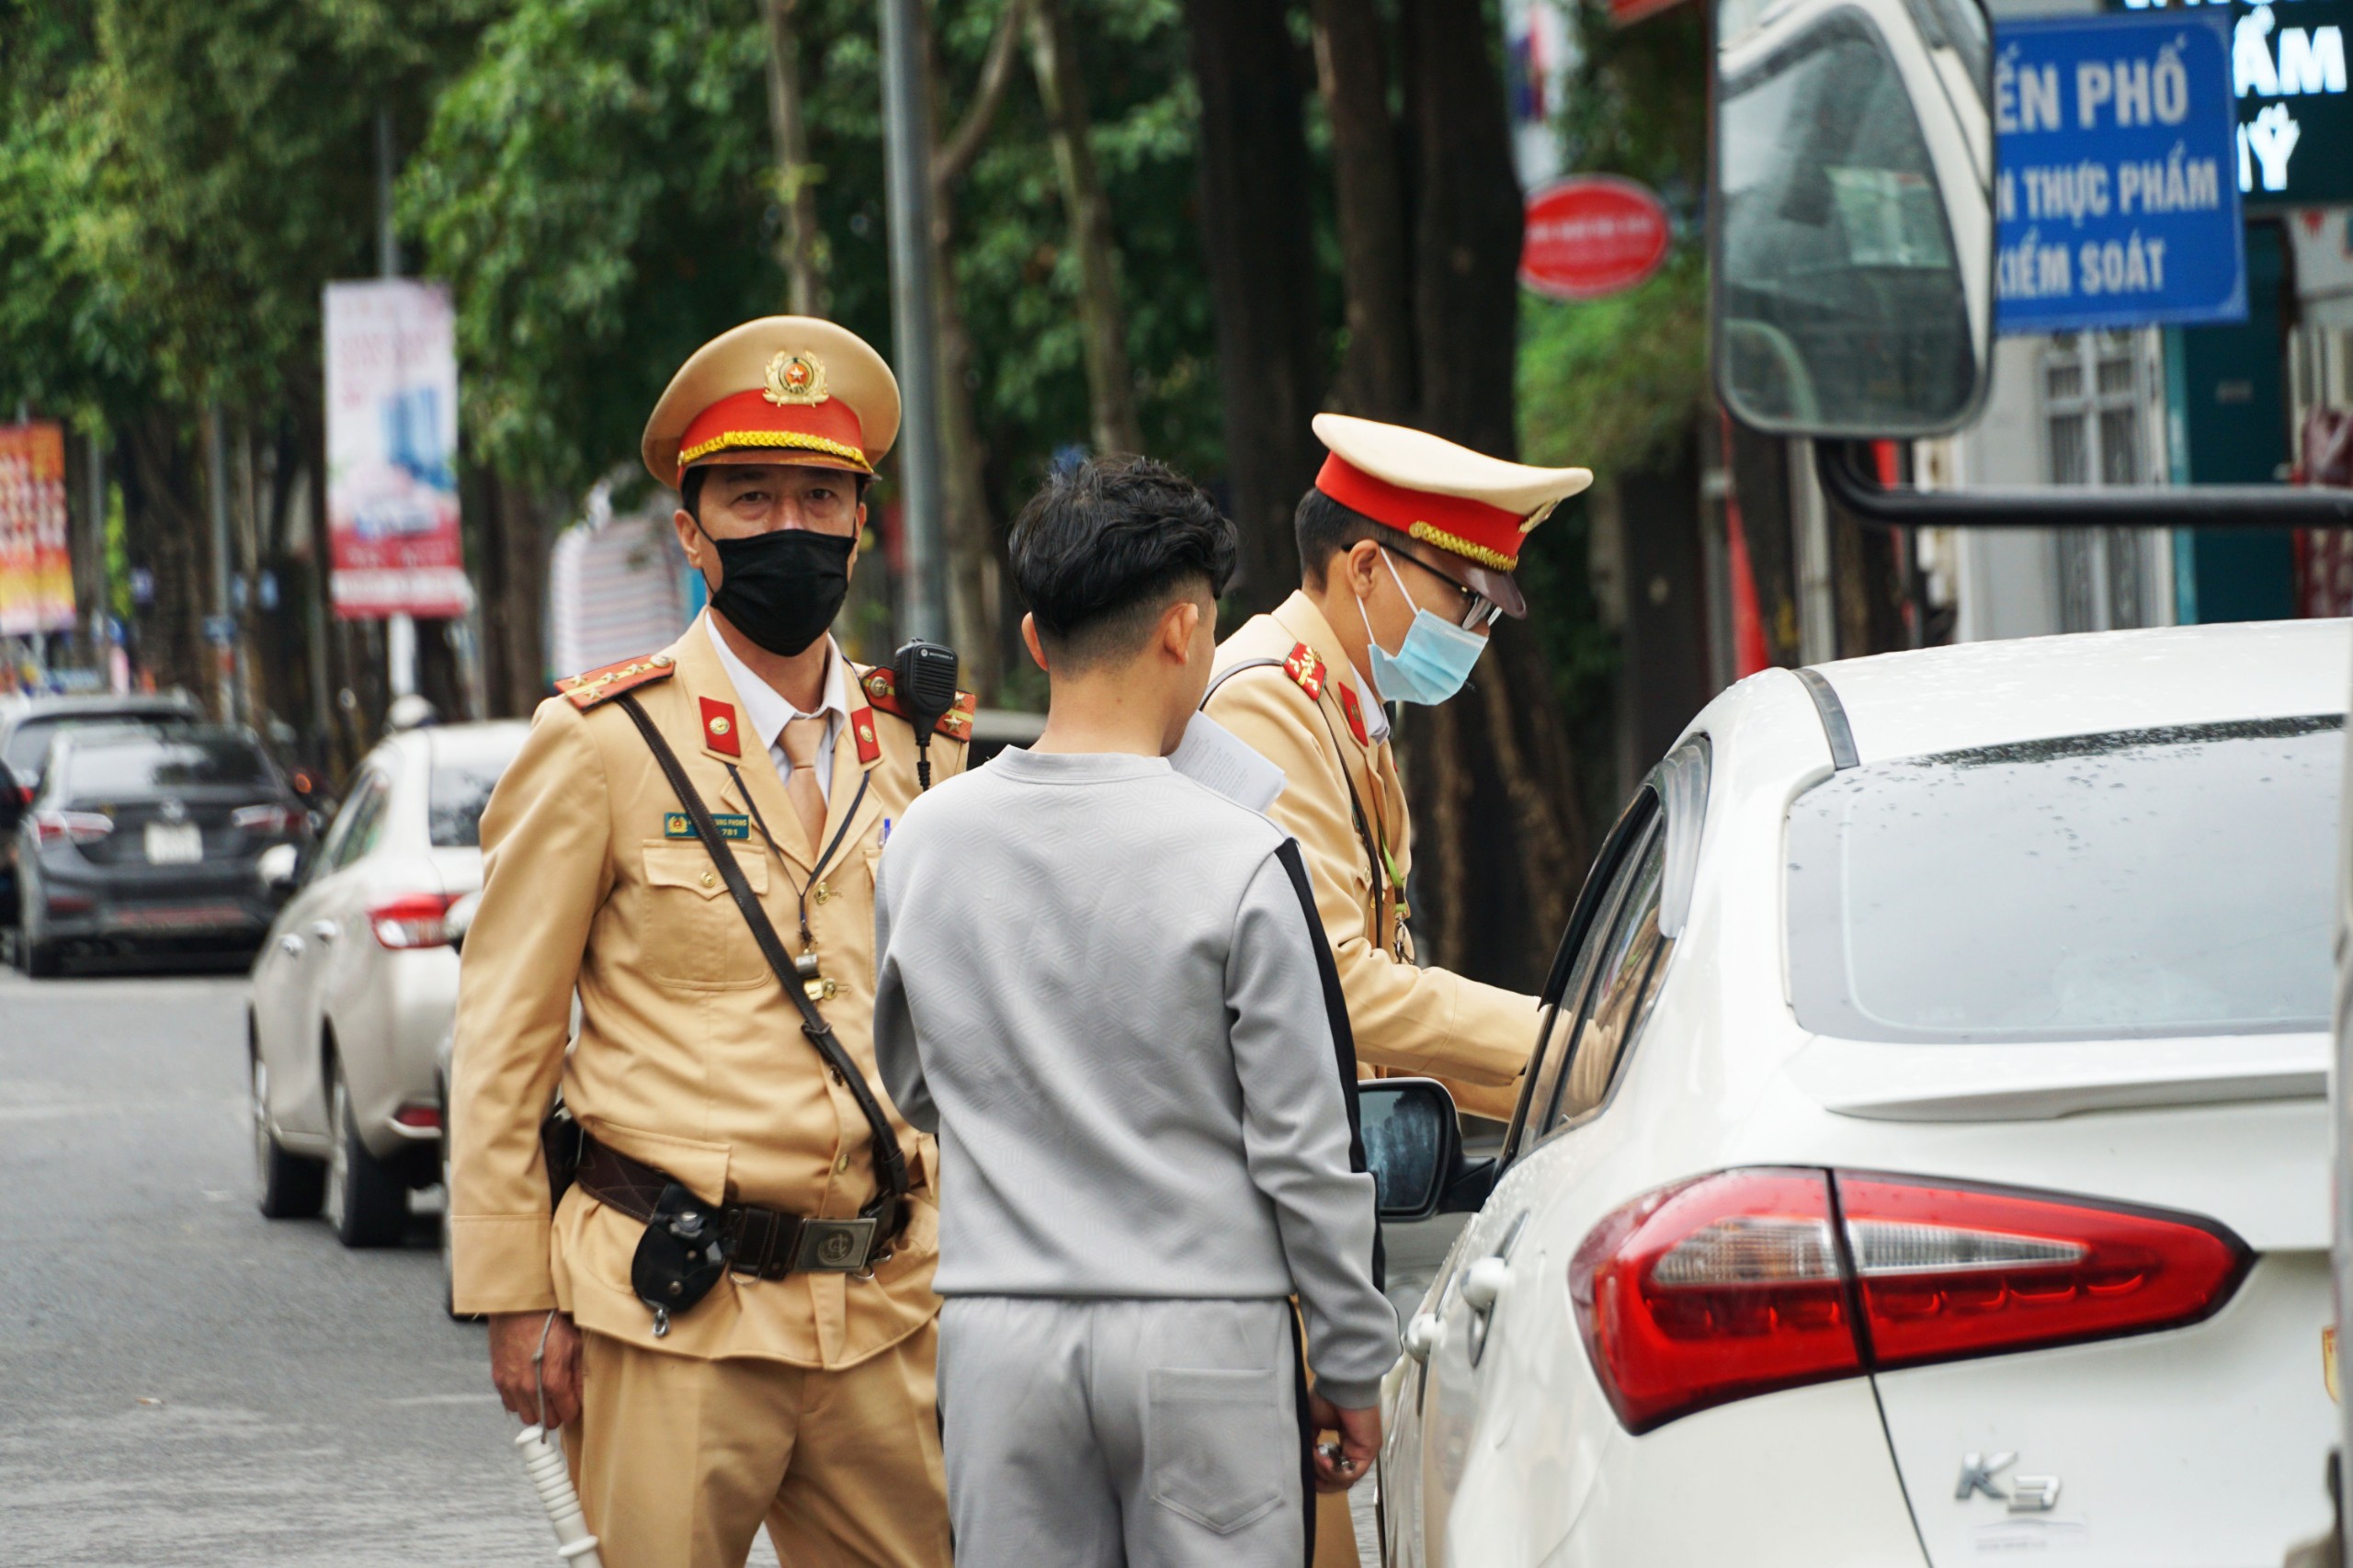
1315, 0, 1415, 422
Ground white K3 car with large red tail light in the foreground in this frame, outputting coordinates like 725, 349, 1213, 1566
1365, 621, 2353, 1568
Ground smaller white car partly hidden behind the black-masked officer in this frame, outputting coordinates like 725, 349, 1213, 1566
247, 722, 529, 1248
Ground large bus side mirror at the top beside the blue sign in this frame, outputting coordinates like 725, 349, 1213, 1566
1709, 0, 1993, 437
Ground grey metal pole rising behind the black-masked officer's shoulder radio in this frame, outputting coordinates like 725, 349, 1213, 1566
880, 0, 949, 642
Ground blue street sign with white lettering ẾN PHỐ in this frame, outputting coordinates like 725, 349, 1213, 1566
1993, 12, 2247, 332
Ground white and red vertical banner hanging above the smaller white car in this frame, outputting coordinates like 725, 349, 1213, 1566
324, 278, 473, 621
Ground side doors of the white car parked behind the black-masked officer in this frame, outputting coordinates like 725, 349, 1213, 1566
254, 763, 391, 1137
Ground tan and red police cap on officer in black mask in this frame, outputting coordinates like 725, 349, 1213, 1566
642, 315, 899, 490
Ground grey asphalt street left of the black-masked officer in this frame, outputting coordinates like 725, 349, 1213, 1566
0, 970, 555, 1568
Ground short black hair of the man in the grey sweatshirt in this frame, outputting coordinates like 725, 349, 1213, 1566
1012, 457, 1240, 668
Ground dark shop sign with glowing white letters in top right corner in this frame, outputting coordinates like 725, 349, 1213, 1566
2109, 0, 2353, 210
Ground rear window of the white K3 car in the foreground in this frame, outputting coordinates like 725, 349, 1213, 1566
1789, 716, 2344, 1040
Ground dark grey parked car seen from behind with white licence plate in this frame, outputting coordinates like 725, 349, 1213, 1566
17, 725, 311, 974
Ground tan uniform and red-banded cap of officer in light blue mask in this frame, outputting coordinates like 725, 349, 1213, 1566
1207, 415, 1593, 1568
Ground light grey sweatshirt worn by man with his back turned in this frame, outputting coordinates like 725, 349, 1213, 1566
875, 751, 1398, 1405
